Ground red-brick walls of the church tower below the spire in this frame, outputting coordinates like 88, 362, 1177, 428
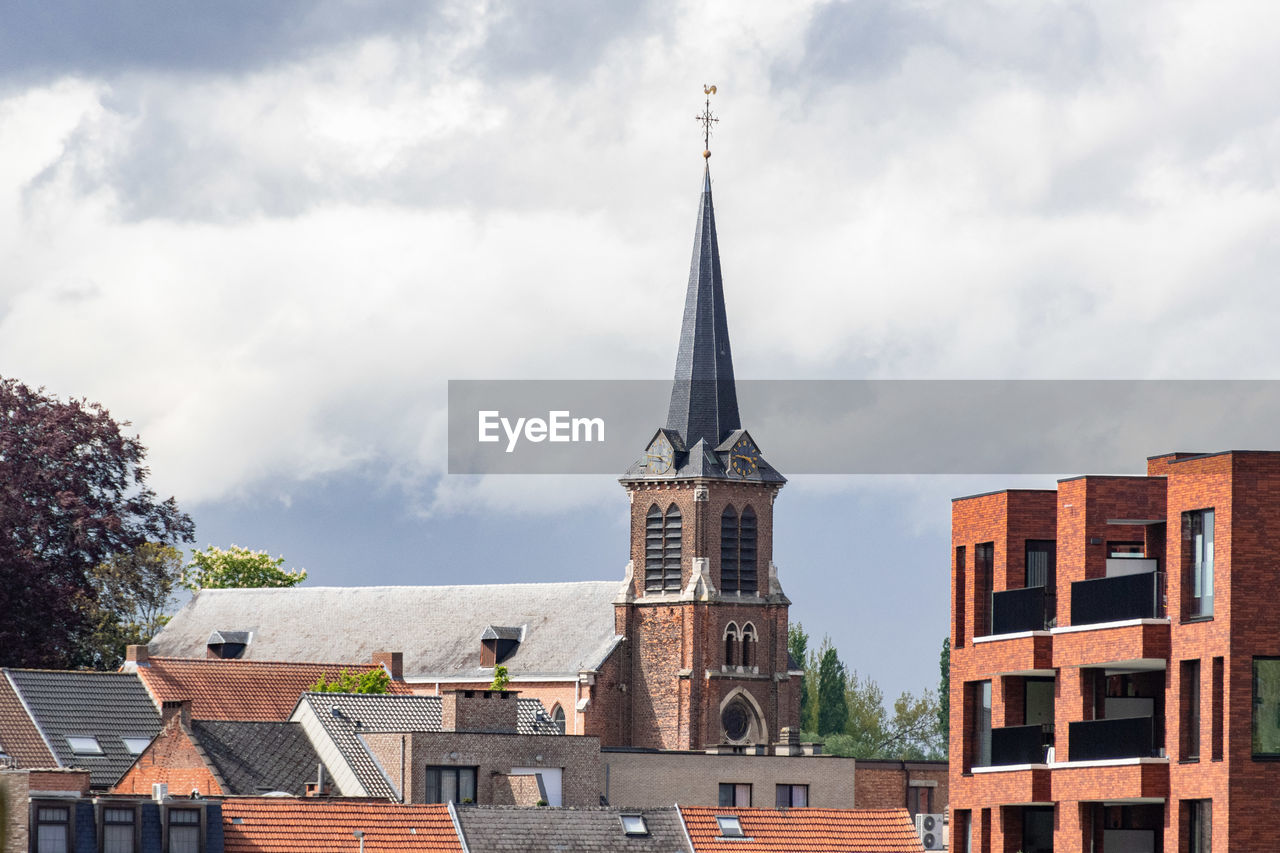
616, 479, 800, 749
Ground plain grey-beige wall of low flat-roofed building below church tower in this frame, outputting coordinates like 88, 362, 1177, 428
600, 751, 861, 808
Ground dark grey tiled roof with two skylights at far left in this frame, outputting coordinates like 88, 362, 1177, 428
5, 670, 160, 788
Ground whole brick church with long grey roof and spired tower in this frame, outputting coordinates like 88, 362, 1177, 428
147, 156, 801, 754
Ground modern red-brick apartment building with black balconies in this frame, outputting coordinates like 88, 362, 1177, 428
950, 451, 1280, 853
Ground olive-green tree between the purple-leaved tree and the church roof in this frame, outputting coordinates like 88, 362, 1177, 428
83, 542, 183, 670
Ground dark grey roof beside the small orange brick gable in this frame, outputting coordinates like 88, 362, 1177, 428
189, 720, 328, 797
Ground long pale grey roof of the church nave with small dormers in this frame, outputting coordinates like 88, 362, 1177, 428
150, 579, 621, 680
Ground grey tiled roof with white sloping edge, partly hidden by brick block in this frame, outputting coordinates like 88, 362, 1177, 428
302, 693, 559, 797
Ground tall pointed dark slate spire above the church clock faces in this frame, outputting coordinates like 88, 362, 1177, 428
667, 167, 741, 447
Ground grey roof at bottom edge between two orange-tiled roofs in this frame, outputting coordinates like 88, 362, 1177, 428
457, 806, 690, 853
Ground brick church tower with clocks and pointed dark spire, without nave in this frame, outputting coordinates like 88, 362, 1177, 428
614, 157, 800, 752
